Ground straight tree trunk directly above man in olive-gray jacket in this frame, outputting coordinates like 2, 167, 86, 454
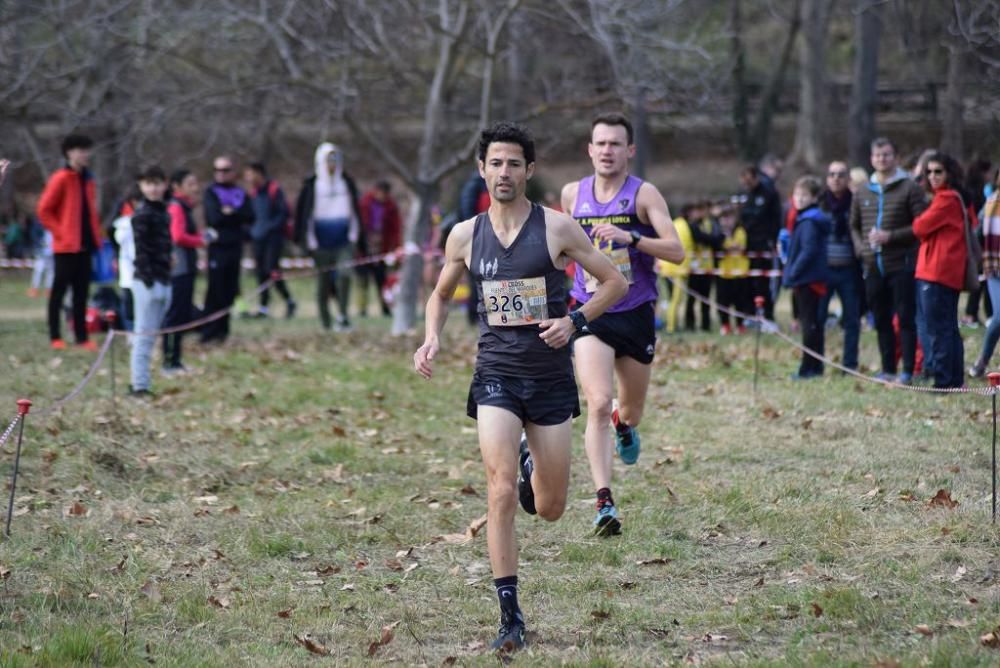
847, 0, 882, 169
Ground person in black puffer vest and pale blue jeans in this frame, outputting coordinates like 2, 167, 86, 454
129, 167, 172, 397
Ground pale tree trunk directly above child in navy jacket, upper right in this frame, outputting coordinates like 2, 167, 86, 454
789, 0, 831, 170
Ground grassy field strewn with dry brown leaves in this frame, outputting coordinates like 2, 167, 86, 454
0, 273, 1000, 666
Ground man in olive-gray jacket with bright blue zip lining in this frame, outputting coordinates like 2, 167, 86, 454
850, 137, 927, 384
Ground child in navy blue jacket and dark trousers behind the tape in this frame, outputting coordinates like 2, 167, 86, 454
782, 176, 832, 380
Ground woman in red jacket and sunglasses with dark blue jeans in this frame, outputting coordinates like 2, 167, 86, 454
913, 153, 978, 388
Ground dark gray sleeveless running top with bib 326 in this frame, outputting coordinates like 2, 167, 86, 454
469, 204, 573, 379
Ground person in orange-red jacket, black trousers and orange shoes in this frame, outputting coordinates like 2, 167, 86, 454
38, 135, 101, 350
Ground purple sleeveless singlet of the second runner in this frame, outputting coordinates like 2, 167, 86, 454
570, 176, 657, 313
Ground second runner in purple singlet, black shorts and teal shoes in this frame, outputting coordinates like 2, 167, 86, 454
562, 113, 684, 536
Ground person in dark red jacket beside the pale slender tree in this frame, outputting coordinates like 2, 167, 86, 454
357, 180, 403, 315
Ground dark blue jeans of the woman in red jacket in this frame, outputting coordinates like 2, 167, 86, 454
917, 280, 965, 387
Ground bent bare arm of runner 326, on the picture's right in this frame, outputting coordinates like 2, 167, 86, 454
539, 210, 628, 348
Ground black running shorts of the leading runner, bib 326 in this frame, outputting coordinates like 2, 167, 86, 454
466, 372, 580, 427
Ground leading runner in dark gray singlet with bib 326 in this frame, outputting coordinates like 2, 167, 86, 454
413, 123, 627, 651
